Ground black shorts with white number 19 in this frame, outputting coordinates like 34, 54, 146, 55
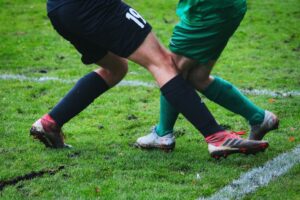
48, 0, 151, 64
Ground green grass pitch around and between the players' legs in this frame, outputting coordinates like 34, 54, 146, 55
0, 0, 300, 200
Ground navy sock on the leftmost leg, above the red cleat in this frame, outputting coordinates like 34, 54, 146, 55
49, 72, 109, 127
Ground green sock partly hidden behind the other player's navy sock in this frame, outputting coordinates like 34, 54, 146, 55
156, 95, 179, 136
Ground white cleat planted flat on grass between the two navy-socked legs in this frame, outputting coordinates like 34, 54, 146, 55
135, 127, 175, 151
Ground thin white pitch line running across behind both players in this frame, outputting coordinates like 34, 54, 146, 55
0, 74, 300, 97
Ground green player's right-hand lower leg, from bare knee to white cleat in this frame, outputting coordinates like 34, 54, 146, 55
189, 67, 279, 140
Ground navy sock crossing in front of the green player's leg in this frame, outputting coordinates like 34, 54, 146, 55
161, 75, 224, 137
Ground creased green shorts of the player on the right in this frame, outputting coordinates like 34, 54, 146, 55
169, 1, 246, 64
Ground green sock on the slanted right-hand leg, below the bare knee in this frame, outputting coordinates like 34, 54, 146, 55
202, 77, 265, 125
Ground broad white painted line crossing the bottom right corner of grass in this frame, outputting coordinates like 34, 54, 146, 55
199, 145, 300, 200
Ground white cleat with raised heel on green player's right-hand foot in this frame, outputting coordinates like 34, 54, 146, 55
248, 110, 279, 140
